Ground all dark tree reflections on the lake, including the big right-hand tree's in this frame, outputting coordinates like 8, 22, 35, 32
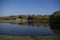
9, 21, 60, 35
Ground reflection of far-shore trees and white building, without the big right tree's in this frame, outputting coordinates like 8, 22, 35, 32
17, 21, 48, 27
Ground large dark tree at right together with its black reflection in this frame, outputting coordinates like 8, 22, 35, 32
49, 11, 60, 34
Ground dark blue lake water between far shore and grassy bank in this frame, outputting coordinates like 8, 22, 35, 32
0, 23, 55, 36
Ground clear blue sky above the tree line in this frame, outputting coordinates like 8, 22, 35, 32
0, 0, 60, 16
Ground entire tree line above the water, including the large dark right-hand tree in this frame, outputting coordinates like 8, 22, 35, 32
0, 11, 60, 22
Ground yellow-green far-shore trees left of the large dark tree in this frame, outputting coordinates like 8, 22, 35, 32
0, 15, 49, 22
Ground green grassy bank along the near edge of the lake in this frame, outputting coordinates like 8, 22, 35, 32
0, 36, 60, 40
